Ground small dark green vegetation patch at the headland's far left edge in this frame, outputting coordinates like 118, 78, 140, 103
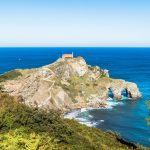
0, 70, 22, 82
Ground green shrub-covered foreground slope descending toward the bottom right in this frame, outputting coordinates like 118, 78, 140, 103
0, 93, 144, 150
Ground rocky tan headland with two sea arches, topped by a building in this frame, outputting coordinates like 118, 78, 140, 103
0, 57, 141, 111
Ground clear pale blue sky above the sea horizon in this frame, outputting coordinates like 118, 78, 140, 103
0, 0, 150, 47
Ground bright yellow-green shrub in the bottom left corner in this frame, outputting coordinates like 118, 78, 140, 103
0, 128, 58, 150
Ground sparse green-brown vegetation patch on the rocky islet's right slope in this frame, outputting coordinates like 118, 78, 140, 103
65, 75, 112, 101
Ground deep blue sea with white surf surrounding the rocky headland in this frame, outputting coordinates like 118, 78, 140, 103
0, 48, 150, 147
